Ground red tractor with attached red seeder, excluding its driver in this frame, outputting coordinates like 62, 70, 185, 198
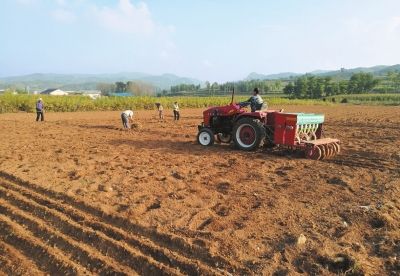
197, 91, 340, 160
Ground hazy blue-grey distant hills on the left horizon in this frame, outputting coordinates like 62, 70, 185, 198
0, 72, 202, 91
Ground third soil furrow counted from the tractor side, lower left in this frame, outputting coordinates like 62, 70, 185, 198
0, 185, 178, 275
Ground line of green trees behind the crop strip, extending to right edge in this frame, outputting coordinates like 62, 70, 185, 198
97, 72, 400, 99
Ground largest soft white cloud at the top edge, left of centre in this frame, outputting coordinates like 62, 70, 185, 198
93, 0, 157, 34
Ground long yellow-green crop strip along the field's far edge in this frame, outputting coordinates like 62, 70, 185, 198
0, 94, 330, 113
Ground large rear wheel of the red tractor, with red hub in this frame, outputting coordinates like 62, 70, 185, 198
232, 118, 266, 151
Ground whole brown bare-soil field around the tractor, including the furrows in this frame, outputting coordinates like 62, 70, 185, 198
0, 106, 400, 275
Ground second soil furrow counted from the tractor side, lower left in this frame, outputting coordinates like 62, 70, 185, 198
1, 178, 220, 275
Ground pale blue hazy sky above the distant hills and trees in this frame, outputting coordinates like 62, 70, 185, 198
0, 0, 400, 82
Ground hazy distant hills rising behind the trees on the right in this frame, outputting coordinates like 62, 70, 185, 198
245, 64, 400, 80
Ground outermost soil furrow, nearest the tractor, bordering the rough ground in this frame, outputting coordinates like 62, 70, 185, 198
0, 171, 244, 274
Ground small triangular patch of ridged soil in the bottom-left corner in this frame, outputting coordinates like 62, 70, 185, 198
0, 240, 45, 276
